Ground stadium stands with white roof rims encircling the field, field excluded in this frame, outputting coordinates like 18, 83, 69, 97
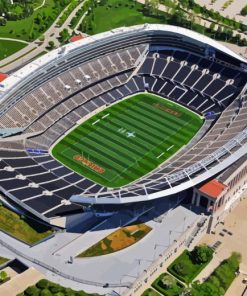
0, 25, 247, 223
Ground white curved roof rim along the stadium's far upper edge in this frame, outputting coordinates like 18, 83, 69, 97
0, 24, 247, 100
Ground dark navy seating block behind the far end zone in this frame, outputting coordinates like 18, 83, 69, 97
138, 50, 247, 114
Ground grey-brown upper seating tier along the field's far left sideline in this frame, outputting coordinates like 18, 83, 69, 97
0, 46, 145, 128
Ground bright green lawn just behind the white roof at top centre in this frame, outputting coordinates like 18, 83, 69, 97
81, 0, 165, 34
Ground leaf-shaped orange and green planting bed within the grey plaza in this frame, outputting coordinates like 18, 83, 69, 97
77, 223, 152, 258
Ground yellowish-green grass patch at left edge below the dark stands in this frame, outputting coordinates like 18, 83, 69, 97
0, 205, 53, 244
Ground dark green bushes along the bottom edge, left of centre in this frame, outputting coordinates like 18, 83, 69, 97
17, 279, 99, 296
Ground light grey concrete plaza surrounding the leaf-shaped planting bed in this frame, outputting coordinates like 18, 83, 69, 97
0, 201, 198, 294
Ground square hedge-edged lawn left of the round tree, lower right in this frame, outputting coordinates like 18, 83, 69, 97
167, 250, 212, 284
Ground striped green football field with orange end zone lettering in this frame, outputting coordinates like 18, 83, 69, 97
52, 93, 203, 188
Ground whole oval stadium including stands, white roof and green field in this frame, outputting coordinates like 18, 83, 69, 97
0, 24, 247, 224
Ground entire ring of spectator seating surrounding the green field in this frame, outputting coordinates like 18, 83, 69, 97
0, 41, 247, 218
